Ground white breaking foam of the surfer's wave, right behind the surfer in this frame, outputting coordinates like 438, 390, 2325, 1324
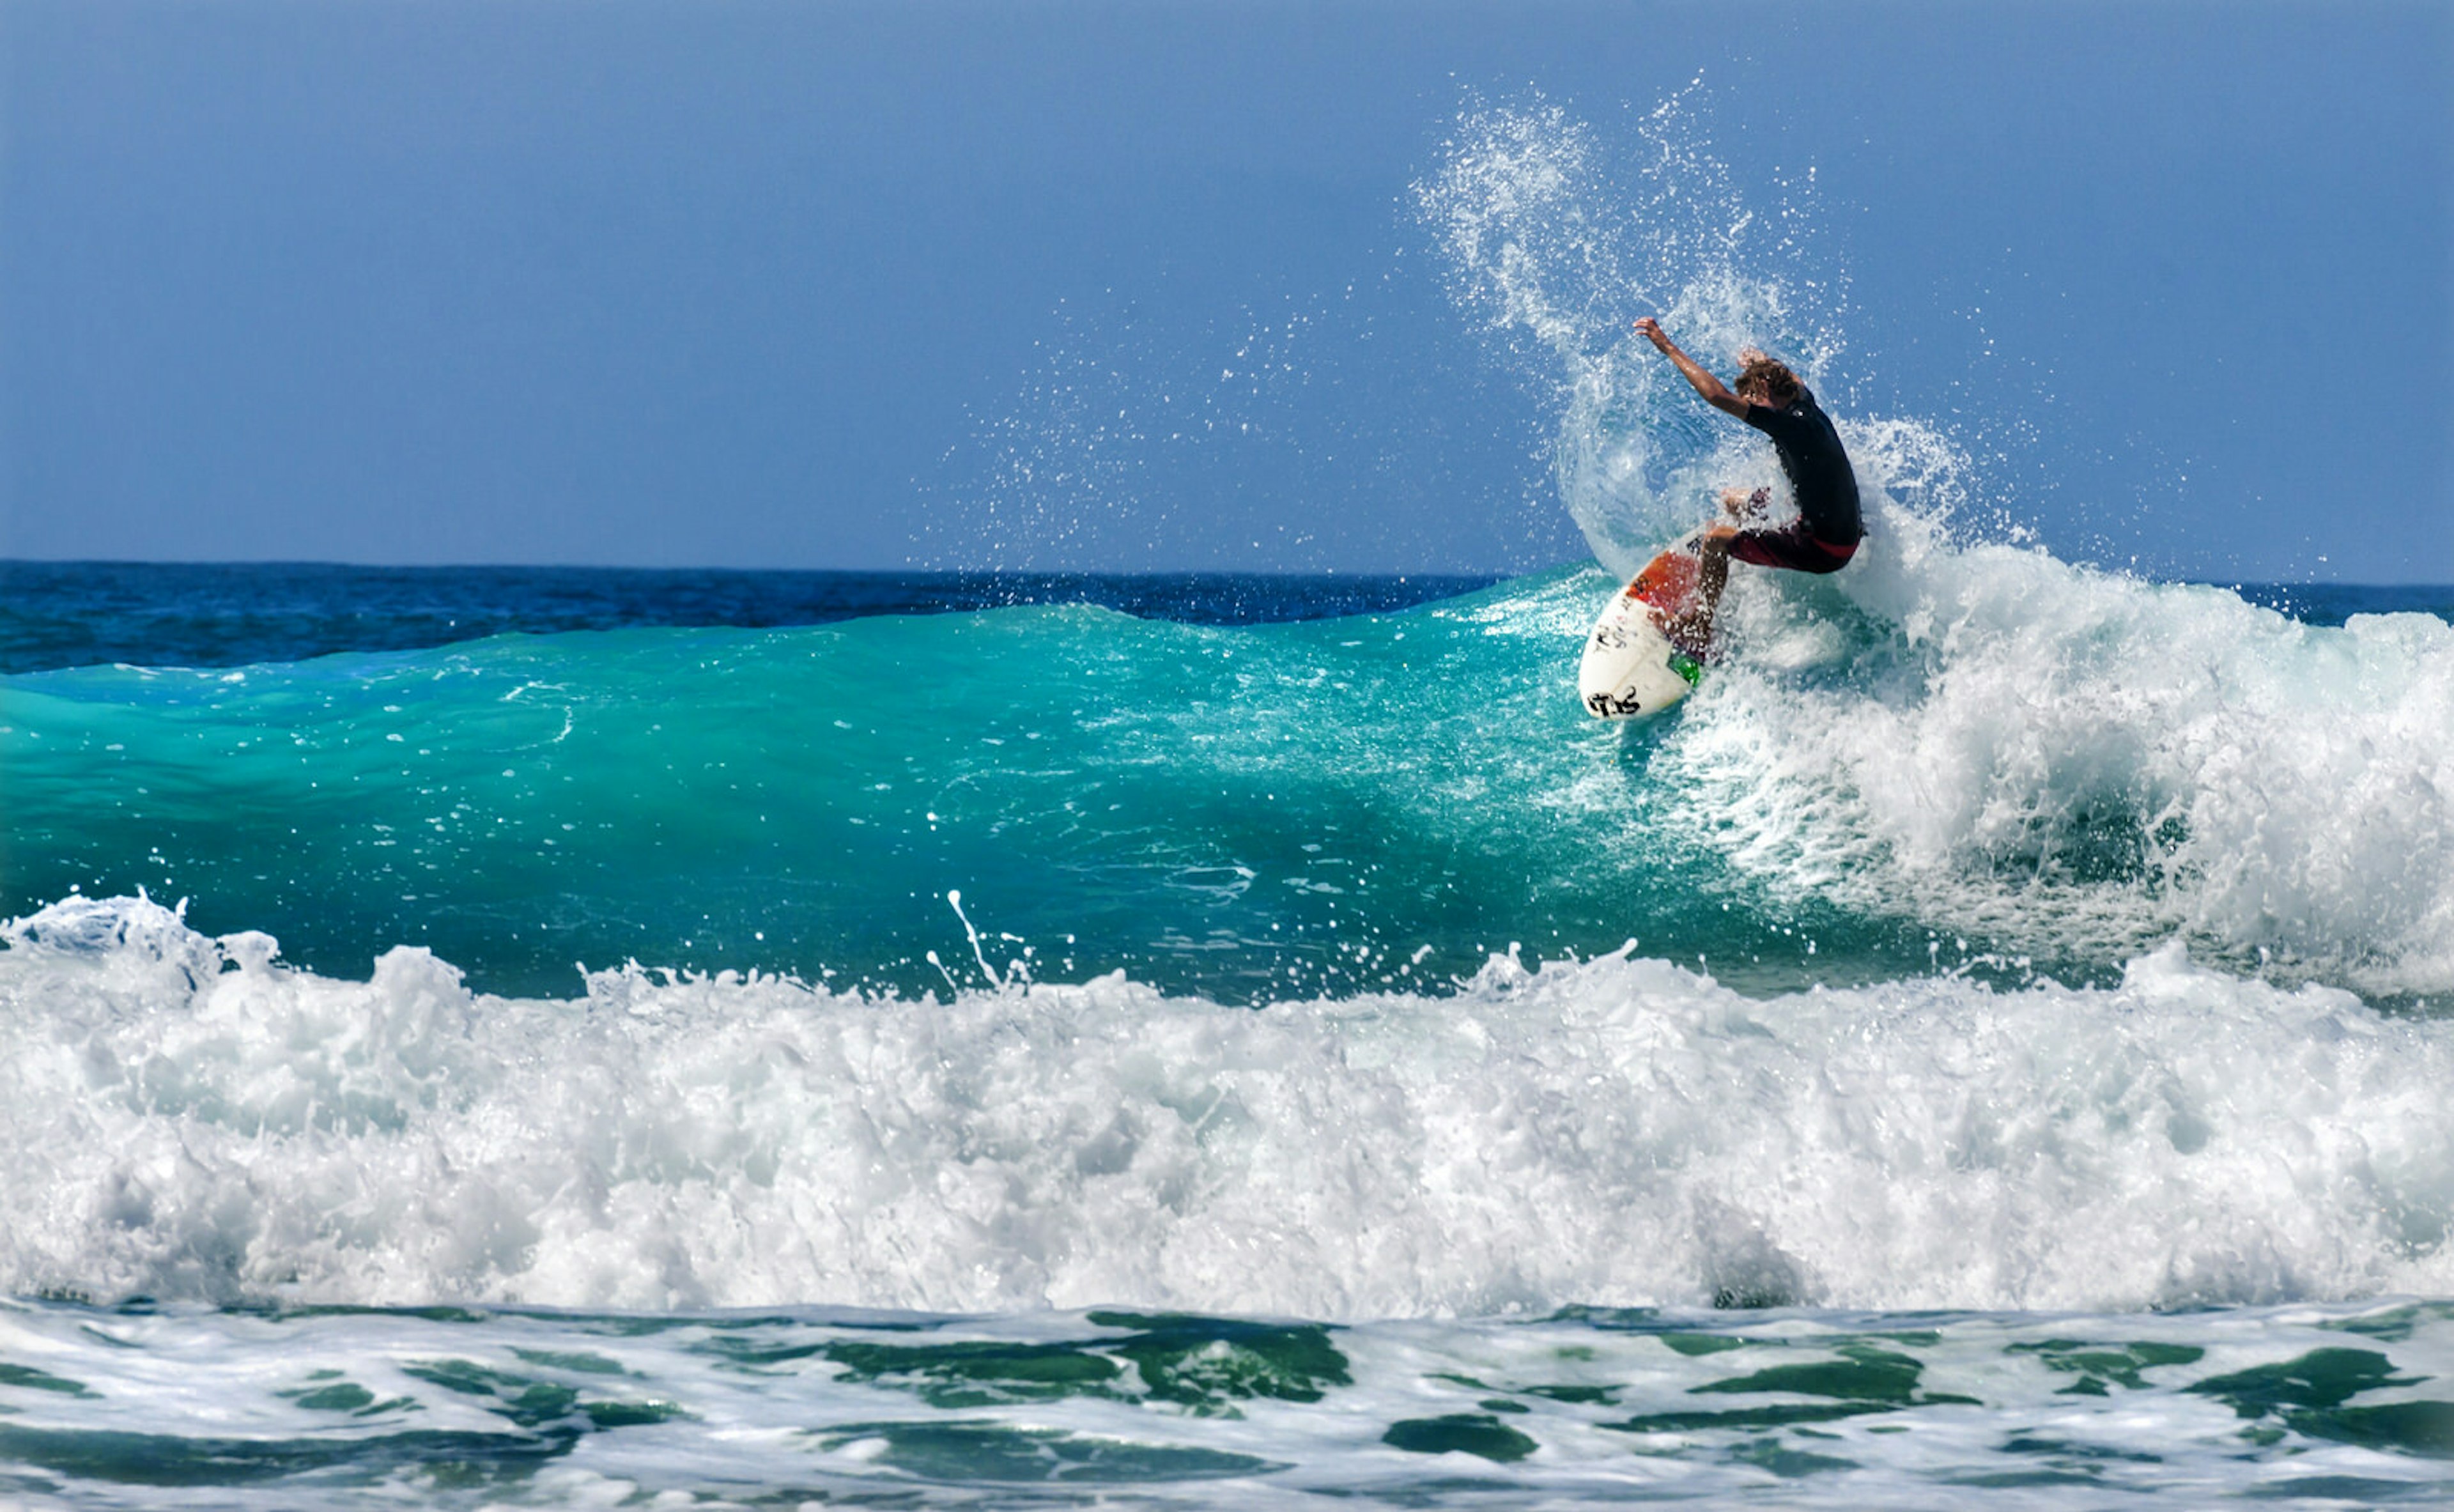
1656, 513, 2454, 994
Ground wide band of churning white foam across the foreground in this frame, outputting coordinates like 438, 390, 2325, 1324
0, 899, 2454, 1318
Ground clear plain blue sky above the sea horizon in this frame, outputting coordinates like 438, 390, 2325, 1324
0, 0, 2454, 582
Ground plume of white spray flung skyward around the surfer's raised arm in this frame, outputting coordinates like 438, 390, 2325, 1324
1414, 84, 1848, 579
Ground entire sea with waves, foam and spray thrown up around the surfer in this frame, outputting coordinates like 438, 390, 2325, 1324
0, 111, 2454, 1509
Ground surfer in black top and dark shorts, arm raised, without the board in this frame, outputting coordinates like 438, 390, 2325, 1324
1637, 316, 1865, 651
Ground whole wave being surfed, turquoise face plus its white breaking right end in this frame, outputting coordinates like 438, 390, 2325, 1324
0, 552, 2454, 1004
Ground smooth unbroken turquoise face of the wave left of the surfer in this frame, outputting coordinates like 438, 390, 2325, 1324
0, 572, 1926, 999
